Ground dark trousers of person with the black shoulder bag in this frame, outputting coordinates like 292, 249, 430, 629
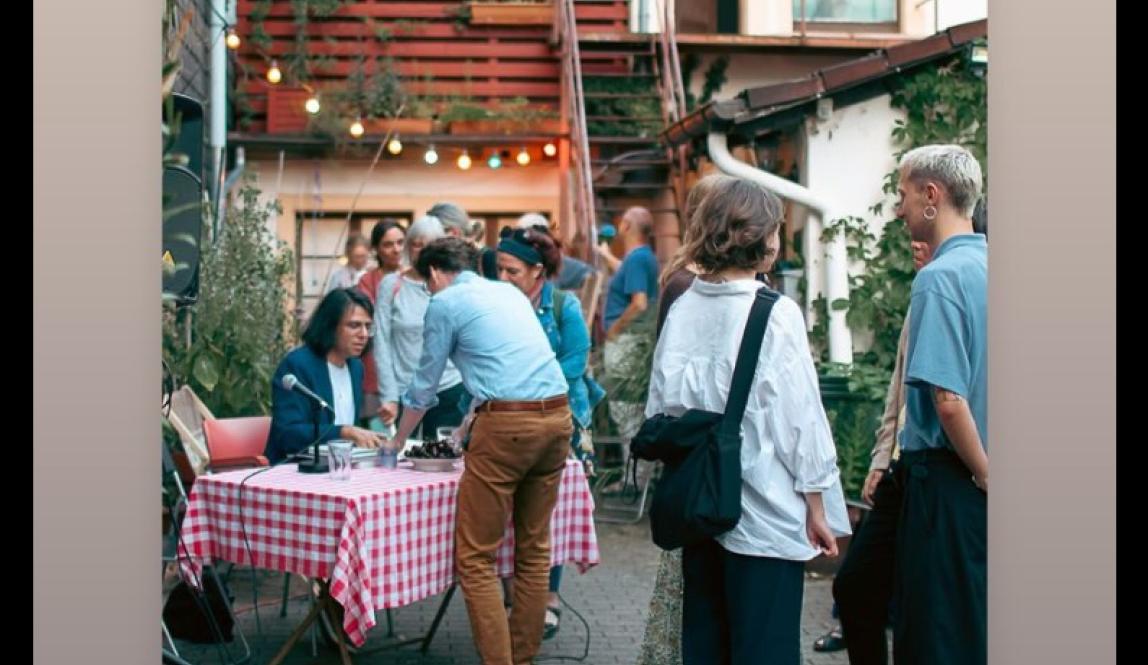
682, 540, 805, 665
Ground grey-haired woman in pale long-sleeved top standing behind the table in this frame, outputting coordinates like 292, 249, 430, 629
374, 215, 471, 439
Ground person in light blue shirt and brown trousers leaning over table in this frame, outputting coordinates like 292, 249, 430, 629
383, 238, 574, 663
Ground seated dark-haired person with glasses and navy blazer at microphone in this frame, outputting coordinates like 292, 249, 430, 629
265, 288, 380, 464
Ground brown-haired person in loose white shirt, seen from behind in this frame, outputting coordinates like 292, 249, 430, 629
645, 178, 850, 665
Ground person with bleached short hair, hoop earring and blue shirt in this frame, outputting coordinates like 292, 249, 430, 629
893, 145, 988, 665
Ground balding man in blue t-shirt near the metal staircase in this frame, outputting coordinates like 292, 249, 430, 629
598, 207, 658, 439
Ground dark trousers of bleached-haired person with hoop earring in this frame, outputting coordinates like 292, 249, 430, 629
893, 450, 988, 665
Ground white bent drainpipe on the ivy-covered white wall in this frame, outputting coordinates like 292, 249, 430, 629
706, 132, 853, 364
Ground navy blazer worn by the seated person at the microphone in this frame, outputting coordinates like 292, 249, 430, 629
264, 345, 363, 464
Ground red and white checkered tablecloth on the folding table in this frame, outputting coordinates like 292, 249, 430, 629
180, 459, 598, 645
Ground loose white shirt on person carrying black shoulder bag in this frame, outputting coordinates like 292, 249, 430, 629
645, 279, 850, 560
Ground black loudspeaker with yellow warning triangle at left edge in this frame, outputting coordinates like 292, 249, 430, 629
163, 167, 203, 304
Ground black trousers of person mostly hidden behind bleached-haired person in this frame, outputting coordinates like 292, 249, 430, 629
833, 464, 903, 665
